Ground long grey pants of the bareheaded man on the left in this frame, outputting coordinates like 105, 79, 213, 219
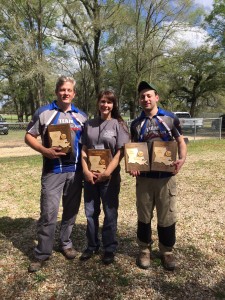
34, 172, 83, 260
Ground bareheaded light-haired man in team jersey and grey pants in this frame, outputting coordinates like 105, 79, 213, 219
25, 76, 87, 272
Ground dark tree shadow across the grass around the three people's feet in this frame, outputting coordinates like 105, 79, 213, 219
0, 217, 225, 299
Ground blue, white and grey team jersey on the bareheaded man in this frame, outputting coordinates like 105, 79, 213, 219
27, 100, 87, 174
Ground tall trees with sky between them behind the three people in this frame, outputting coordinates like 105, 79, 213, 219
0, 0, 225, 121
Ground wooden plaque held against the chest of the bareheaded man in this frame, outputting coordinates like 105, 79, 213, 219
48, 124, 72, 153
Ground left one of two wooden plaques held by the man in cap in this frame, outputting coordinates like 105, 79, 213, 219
124, 142, 150, 172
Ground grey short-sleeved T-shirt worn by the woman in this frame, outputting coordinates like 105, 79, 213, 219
82, 117, 129, 156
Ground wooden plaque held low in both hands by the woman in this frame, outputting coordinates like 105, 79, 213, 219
87, 149, 112, 173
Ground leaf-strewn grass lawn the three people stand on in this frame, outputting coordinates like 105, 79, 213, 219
0, 140, 225, 300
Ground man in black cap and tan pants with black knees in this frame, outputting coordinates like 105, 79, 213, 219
130, 81, 187, 271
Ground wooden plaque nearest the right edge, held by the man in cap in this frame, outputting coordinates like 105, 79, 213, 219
151, 141, 177, 172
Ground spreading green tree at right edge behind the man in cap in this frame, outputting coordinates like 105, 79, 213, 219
159, 45, 225, 117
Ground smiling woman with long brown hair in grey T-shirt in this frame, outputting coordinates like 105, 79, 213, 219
80, 90, 129, 264
